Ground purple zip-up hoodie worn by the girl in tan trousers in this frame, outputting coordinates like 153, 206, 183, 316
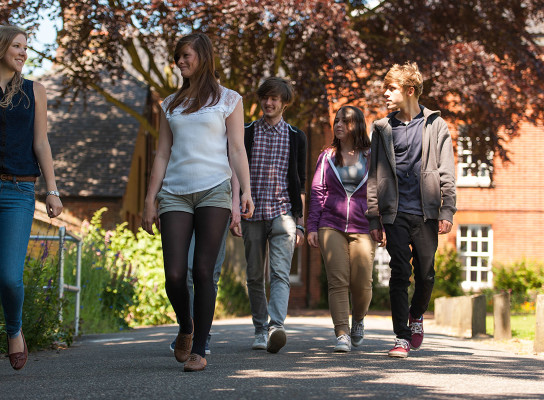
306, 149, 370, 233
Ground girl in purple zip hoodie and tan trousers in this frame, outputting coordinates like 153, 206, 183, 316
307, 106, 376, 352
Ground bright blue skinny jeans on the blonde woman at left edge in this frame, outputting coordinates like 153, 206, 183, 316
0, 181, 34, 338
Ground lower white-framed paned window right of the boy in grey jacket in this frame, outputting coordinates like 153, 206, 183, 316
456, 224, 493, 291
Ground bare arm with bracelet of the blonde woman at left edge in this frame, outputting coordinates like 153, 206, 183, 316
33, 82, 62, 218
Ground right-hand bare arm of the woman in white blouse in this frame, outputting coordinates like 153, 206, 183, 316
225, 100, 255, 218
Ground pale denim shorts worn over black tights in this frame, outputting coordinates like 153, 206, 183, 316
157, 179, 232, 215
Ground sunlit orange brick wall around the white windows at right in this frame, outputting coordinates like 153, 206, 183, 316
448, 124, 544, 263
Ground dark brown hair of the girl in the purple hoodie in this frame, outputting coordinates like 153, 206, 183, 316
330, 106, 370, 167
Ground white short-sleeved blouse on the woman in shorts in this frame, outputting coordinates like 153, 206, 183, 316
161, 86, 242, 195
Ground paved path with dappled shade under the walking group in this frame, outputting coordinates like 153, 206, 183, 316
0, 316, 544, 400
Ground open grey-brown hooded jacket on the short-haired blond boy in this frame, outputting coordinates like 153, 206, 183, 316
366, 107, 457, 230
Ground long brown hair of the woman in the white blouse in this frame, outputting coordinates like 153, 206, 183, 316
168, 32, 221, 114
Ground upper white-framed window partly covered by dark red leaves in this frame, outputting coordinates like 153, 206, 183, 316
457, 136, 493, 187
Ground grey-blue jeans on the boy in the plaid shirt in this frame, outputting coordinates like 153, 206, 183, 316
242, 213, 297, 334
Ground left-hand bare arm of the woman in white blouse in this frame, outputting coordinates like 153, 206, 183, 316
142, 110, 173, 235
